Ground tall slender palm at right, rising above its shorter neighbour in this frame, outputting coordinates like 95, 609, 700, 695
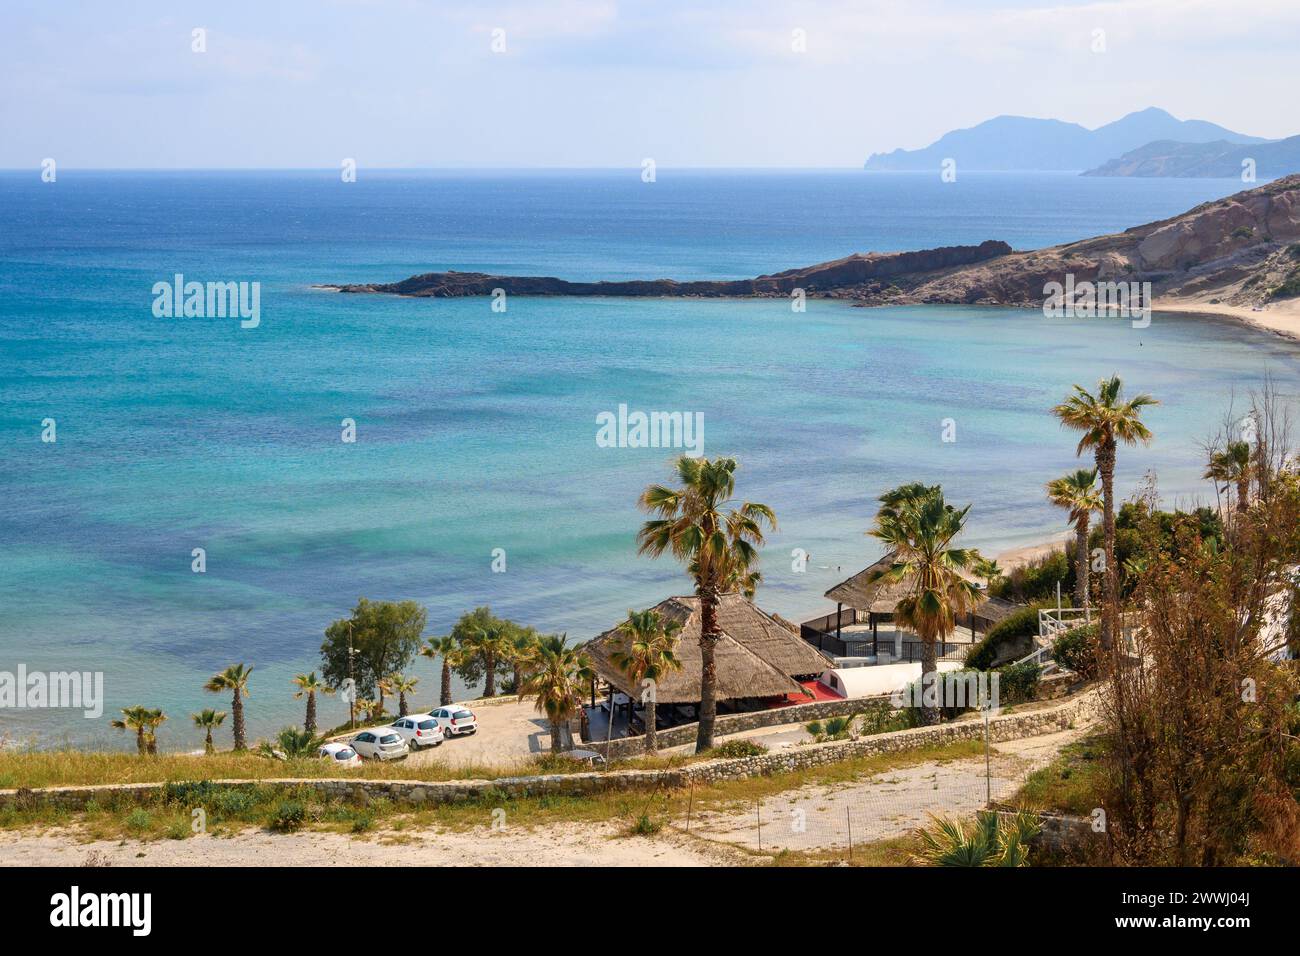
1052, 375, 1160, 650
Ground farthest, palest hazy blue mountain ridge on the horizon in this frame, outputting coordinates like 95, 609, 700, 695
863, 107, 1268, 178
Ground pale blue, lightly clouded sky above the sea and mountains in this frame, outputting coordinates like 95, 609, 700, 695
0, 0, 1300, 169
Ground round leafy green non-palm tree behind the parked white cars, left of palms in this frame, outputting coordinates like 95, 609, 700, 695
321, 597, 428, 711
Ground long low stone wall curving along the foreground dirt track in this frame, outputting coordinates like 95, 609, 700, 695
0, 692, 1096, 809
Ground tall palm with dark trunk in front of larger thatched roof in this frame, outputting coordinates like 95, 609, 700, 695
637, 455, 776, 753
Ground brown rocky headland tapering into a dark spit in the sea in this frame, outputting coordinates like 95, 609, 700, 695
324, 176, 1300, 306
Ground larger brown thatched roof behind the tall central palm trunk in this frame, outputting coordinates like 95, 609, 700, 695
582, 594, 829, 704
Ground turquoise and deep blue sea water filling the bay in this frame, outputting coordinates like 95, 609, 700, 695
0, 170, 1300, 748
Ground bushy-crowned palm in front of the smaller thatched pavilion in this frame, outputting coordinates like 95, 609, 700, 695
867, 485, 979, 724
